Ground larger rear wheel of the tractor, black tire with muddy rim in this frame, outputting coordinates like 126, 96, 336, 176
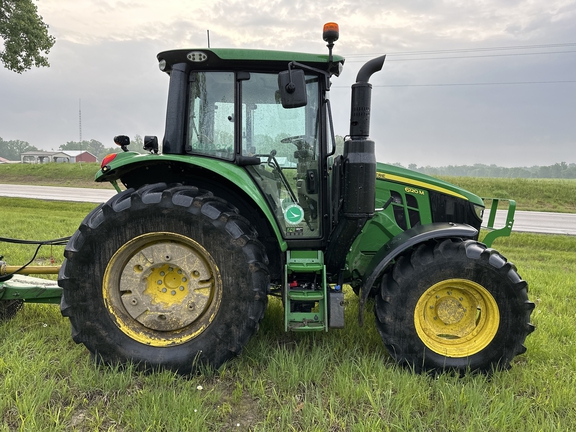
59, 183, 268, 374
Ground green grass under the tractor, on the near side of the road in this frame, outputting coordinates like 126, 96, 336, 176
0, 198, 576, 432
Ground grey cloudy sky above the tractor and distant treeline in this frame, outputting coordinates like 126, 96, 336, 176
0, 0, 576, 167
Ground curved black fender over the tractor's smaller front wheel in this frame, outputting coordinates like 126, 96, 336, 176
358, 222, 478, 326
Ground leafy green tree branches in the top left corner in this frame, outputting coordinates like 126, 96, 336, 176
0, 0, 55, 73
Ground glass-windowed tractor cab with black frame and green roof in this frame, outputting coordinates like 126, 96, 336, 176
158, 49, 344, 240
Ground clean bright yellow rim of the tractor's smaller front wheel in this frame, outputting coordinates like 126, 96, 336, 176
414, 279, 500, 358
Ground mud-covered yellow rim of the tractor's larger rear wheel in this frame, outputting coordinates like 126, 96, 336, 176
102, 232, 222, 347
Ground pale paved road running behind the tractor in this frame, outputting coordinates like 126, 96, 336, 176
0, 184, 576, 235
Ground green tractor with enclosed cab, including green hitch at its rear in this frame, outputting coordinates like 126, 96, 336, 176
0, 23, 534, 374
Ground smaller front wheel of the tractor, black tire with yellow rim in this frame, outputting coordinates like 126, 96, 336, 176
375, 239, 534, 373
